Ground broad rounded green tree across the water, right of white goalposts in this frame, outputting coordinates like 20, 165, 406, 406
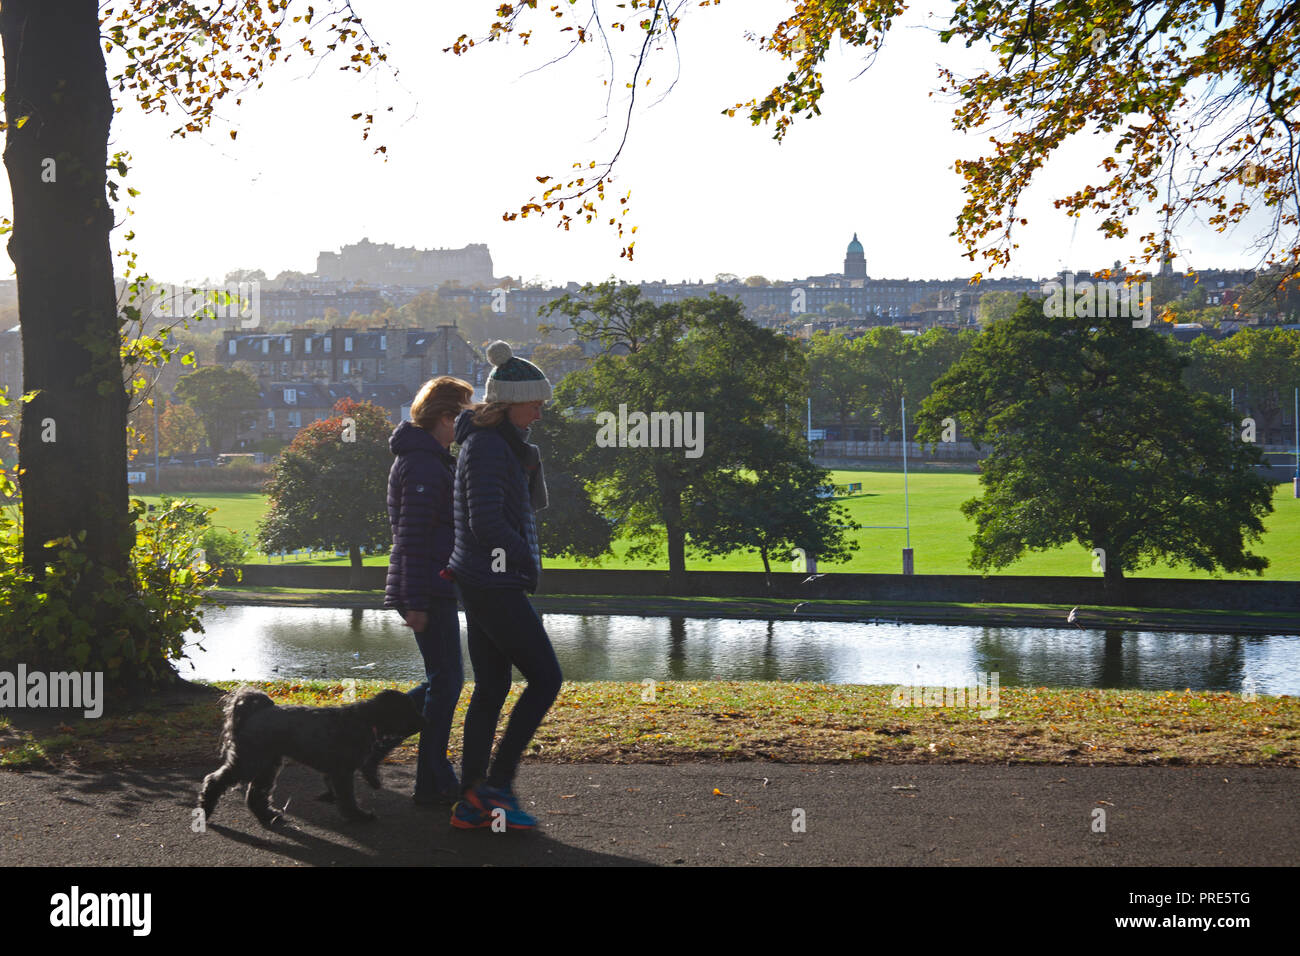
918, 300, 1273, 585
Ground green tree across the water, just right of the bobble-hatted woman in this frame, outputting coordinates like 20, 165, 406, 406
547, 282, 806, 589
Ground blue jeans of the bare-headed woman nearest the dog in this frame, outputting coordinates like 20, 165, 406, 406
407, 597, 465, 800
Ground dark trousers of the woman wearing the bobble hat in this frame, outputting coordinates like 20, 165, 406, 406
456, 581, 563, 790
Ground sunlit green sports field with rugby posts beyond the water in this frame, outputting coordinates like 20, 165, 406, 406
134, 471, 1300, 580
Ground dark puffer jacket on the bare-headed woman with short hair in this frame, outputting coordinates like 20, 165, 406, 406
384, 421, 456, 611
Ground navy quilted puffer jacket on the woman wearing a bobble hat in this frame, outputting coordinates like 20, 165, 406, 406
447, 410, 546, 592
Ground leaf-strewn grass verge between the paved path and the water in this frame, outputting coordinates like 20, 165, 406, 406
0, 680, 1300, 770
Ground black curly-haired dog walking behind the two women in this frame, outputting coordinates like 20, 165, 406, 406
199, 687, 424, 829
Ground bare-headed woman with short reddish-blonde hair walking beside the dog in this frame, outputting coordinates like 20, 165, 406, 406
374, 376, 475, 806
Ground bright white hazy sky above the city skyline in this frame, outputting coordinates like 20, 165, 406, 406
0, 0, 1255, 282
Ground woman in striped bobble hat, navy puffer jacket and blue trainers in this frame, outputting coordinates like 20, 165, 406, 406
443, 342, 562, 830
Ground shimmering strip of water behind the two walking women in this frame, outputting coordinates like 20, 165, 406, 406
181, 607, 1300, 695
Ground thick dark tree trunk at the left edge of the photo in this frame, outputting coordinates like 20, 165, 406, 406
0, 0, 131, 582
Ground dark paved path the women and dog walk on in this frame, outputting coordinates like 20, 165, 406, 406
0, 762, 1300, 866
